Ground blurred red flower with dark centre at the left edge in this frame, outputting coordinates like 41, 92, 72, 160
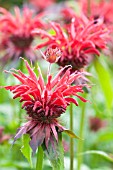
0, 7, 44, 65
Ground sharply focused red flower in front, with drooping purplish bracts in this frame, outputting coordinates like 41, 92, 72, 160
5, 58, 87, 152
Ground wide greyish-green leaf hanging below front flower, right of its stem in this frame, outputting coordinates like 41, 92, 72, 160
45, 133, 64, 170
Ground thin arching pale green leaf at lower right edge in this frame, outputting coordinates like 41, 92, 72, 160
79, 150, 113, 162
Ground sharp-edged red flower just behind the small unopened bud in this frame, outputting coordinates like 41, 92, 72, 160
33, 17, 109, 70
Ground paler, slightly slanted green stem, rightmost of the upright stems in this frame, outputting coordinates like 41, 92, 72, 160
77, 95, 86, 170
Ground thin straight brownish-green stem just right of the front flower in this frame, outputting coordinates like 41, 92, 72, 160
70, 103, 74, 170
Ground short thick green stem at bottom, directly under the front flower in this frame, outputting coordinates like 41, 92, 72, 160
36, 146, 44, 170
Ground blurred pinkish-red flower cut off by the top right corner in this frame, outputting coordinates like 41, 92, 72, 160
81, 0, 113, 60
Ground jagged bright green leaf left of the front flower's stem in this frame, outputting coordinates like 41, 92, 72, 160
20, 134, 32, 168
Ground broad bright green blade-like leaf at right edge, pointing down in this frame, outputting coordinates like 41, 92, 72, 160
94, 59, 113, 109
